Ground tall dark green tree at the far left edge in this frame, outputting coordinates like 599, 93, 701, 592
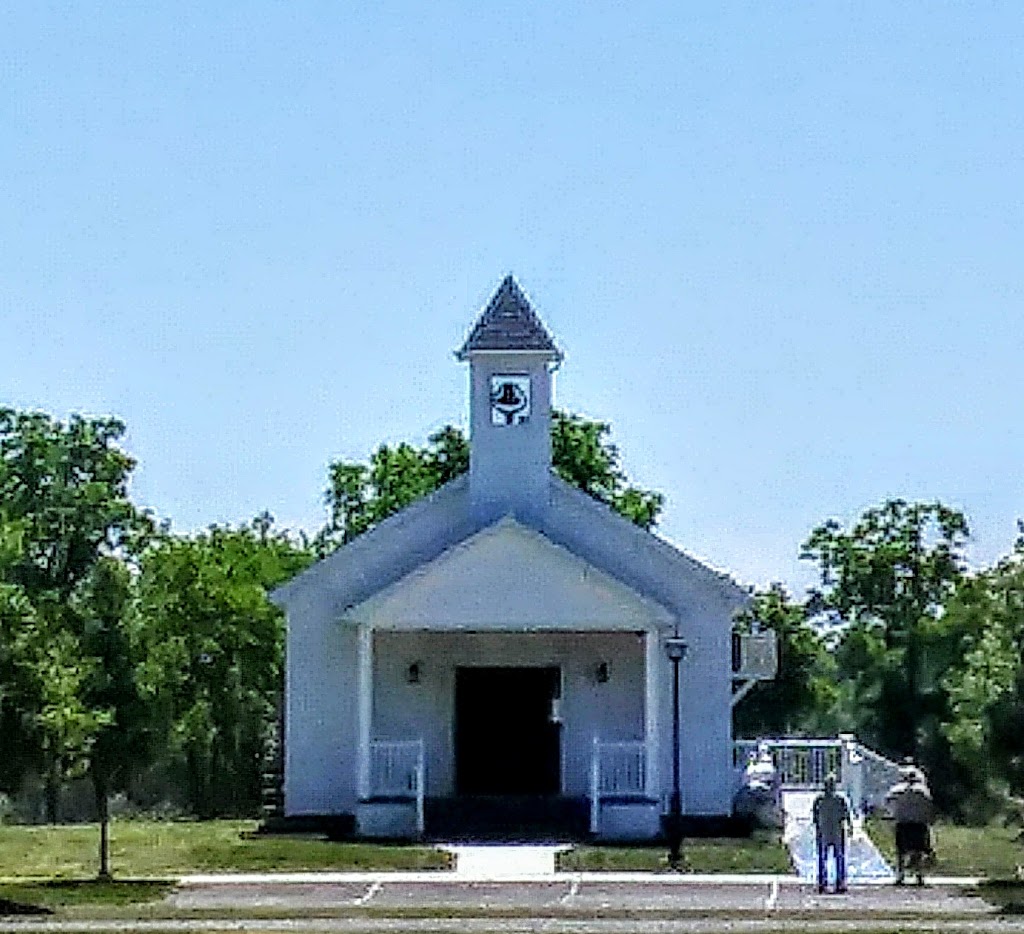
0, 409, 151, 821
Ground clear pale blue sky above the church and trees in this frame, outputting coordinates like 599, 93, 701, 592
0, 0, 1024, 590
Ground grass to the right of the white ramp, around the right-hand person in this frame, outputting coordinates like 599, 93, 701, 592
867, 818, 1024, 879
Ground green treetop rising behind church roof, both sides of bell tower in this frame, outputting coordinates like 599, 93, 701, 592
315, 411, 665, 553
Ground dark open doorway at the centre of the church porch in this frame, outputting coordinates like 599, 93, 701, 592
455, 668, 561, 795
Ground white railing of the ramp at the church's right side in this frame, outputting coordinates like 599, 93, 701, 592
732, 733, 899, 813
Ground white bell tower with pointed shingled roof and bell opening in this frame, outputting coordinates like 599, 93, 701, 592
456, 275, 562, 515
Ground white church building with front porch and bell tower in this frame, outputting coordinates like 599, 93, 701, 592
272, 277, 766, 839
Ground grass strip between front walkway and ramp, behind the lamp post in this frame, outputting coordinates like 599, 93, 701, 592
558, 833, 792, 873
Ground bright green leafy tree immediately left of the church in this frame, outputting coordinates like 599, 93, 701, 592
139, 515, 313, 817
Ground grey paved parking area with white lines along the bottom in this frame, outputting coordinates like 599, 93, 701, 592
0, 874, 1024, 934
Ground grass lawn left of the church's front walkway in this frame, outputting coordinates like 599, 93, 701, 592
0, 820, 449, 881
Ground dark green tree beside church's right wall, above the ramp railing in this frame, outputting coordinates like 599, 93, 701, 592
733, 584, 838, 736
